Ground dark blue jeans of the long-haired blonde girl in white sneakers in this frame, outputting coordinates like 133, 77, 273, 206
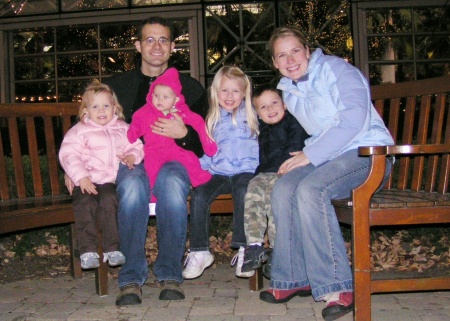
190, 173, 254, 252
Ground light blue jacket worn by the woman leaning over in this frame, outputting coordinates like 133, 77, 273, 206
278, 49, 394, 166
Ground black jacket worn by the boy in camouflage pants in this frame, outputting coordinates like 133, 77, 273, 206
255, 110, 309, 175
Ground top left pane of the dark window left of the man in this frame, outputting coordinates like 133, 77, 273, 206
13, 28, 55, 54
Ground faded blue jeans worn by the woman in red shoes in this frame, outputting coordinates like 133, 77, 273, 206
270, 150, 391, 300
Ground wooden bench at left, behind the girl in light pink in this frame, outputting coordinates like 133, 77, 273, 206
0, 103, 262, 295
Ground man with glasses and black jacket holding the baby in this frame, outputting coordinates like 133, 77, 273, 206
92, 17, 208, 306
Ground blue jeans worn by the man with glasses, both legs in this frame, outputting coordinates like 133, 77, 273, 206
116, 162, 190, 287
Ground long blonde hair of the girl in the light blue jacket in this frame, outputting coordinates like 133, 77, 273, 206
206, 66, 259, 139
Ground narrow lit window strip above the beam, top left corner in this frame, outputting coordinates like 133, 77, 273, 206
0, 0, 58, 17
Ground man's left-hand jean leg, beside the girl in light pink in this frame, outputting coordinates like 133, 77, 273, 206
116, 164, 150, 287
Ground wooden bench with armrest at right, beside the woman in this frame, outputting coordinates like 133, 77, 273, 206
333, 76, 450, 321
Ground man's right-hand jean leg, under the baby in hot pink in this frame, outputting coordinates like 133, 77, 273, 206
153, 162, 191, 282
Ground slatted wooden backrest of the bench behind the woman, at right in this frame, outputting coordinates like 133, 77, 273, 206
371, 76, 450, 193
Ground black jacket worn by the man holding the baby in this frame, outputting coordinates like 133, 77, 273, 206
103, 61, 208, 157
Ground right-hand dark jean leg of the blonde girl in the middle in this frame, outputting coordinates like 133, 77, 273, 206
230, 173, 254, 248
